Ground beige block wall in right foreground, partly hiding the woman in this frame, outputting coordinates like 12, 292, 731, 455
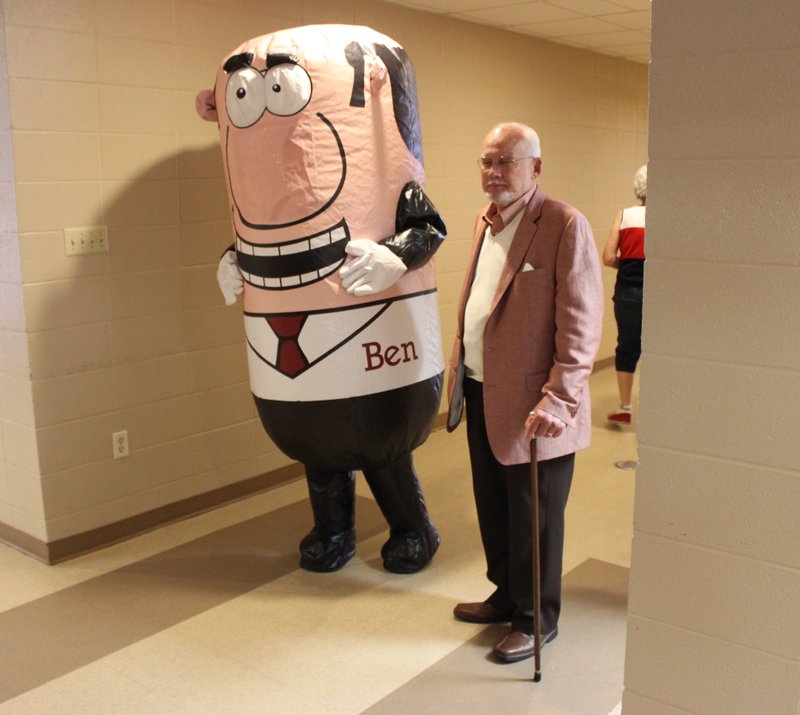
622, 0, 800, 715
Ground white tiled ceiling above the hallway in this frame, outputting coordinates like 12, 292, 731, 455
388, 0, 650, 64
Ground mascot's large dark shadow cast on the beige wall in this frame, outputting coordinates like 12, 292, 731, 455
36, 144, 272, 541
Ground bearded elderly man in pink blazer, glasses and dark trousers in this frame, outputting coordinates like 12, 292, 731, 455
448, 123, 603, 662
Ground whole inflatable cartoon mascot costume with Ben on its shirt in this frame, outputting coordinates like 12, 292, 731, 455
197, 25, 446, 573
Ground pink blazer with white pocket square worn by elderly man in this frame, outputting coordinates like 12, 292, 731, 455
447, 188, 603, 464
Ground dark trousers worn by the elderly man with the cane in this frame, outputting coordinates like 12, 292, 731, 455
464, 378, 575, 633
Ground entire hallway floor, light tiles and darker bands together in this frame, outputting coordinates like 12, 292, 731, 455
0, 369, 636, 715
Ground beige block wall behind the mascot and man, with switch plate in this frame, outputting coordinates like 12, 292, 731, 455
0, 0, 647, 541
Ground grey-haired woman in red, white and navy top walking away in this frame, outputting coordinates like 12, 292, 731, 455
603, 164, 647, 425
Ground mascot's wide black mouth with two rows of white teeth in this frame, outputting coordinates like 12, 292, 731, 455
236, 219, 350, 290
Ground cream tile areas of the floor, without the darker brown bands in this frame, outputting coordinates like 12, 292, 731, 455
0, 370, 636, 715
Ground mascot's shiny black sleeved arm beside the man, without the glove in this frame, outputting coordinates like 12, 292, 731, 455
381, 181, 447, 271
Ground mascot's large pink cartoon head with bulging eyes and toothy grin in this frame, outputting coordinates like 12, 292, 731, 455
198, 25, 433, 314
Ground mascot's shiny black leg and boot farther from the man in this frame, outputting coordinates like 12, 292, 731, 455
300, 466, 356, 571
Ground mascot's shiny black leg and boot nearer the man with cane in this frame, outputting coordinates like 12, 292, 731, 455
364, 454, 439, 573
